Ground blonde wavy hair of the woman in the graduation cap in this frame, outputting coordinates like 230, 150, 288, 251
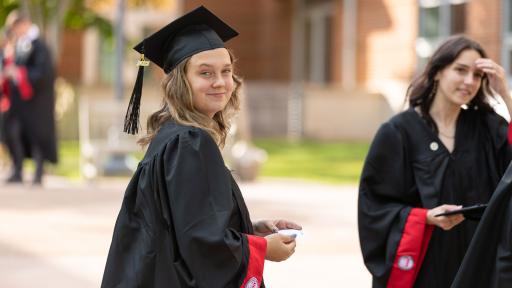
137, 50, 242, 148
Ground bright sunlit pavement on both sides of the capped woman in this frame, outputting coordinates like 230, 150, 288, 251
0, 176, 371, 288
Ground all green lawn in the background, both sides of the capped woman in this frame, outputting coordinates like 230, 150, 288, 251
7, 139, 369, 184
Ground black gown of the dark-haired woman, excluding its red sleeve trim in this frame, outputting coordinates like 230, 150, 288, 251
358, 109, 512, 287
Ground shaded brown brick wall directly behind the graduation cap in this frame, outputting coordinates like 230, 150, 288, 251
184, 0, 293, 81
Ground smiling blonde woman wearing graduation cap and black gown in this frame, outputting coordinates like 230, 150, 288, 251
101, 6, 301, 288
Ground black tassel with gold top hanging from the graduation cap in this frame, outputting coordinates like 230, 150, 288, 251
123, 55, 149, 135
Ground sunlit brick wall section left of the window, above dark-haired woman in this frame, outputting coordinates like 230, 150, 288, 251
357, 0, 419, 85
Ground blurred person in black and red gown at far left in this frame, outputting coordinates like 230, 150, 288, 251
2, 11, 57, 185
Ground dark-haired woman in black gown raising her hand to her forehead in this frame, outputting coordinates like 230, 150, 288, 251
358, 36, 512, 287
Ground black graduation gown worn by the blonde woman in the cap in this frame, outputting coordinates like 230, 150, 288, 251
101, 122, 263, 288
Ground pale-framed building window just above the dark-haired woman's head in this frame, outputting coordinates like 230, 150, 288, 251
416, 0, 469, 69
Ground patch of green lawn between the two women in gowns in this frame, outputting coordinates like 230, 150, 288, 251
255, 139, 369, 184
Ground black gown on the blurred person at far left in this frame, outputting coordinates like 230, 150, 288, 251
3, 38, 58, 163
